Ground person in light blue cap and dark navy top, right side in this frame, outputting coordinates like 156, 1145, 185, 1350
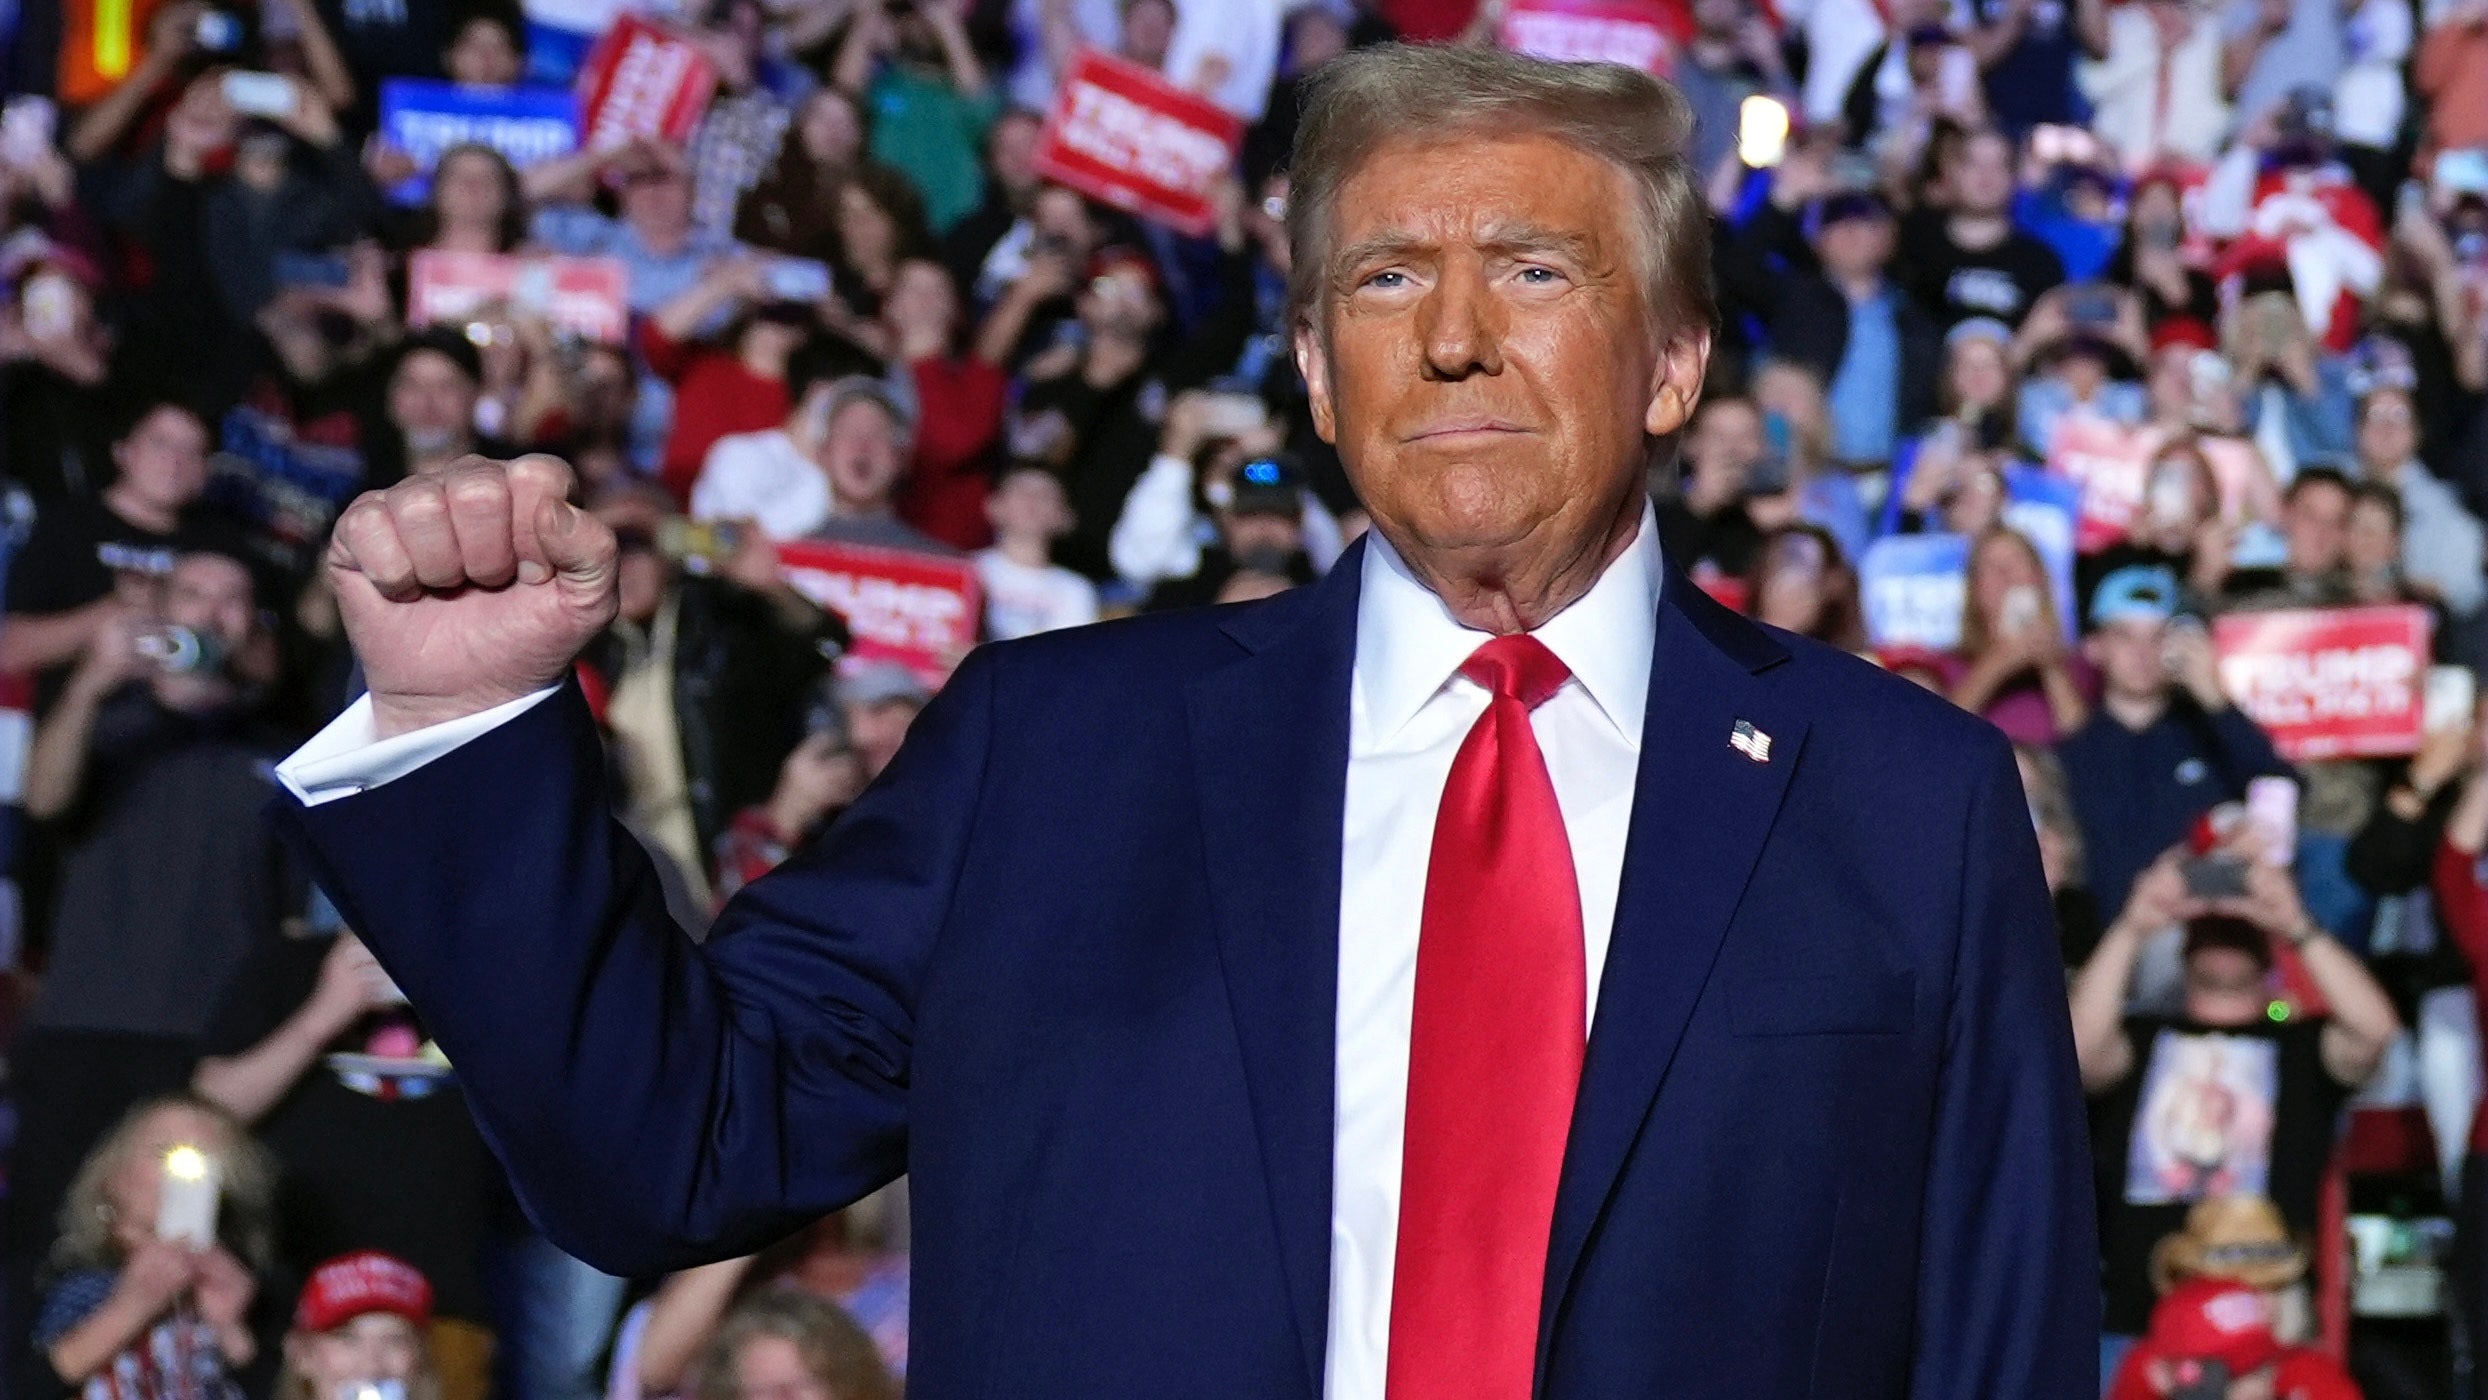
2058, 564, 2289, 908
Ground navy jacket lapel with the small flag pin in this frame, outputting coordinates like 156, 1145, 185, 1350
1538, 569, 1806, 1368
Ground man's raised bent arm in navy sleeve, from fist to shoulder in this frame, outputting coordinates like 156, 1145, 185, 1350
279, 458, 990, 1273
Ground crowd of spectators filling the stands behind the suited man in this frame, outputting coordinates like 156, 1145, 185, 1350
0, 0, 2488, 1400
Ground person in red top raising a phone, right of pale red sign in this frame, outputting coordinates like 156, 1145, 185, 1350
639, 259, 821, 502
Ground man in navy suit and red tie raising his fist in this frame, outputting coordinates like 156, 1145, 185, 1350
284, 50, 2097, 1400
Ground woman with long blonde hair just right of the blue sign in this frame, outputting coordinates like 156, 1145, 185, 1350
1943, 525, 2090, 748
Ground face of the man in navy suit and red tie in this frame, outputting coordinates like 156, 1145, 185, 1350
1296, 134, 1709, 586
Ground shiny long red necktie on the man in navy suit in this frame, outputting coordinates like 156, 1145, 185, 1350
1386, 637, 1585, 1400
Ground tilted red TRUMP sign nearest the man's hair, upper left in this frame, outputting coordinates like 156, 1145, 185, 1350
1037, 50, 1244, 236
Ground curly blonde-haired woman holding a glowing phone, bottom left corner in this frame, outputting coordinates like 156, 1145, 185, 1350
35, 1094, 276, 1400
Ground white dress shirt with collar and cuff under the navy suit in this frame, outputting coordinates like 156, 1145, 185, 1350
276, 507, 1664, 1400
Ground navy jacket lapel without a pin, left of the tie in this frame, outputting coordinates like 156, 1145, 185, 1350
1187, 545, 1363, 1398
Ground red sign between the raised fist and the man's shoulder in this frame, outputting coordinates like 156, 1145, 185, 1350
776, 540, 983, 686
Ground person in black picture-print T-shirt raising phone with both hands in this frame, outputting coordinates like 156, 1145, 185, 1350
2073, 838, 2401, 1335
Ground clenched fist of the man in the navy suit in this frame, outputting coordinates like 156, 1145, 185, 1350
328, 455, 617, 739
